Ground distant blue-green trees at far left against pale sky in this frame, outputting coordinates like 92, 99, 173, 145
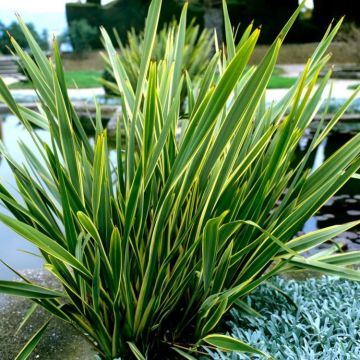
0, 21, 49, 54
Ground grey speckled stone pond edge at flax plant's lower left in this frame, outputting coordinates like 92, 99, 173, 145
0, 269, 95, 360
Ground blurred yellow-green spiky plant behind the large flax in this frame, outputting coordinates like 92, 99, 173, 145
103, 21, 214, 95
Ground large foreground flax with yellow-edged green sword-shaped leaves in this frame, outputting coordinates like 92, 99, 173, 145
0, 0, 360, 360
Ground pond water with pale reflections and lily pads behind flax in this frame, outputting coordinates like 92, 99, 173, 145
0, 112, 360, 279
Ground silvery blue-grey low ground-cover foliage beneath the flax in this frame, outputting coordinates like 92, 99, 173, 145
207, 277, 360, 360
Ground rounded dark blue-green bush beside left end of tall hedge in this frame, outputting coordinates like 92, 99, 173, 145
63, 19, 98, 54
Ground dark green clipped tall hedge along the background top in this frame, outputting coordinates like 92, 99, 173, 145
66, 0, 360, 48
